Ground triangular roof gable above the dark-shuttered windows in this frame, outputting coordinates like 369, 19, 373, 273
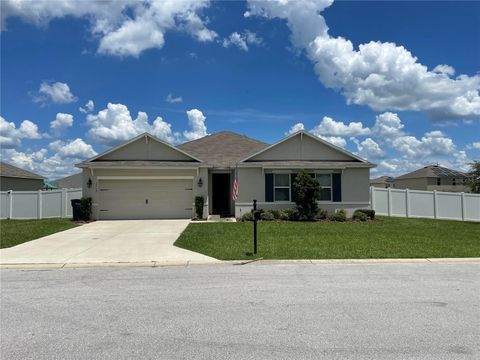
243, 131, 367, 163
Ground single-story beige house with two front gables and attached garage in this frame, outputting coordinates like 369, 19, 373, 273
76, 131, 375, 219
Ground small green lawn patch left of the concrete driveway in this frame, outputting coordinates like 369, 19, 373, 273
0, 219, 78, 248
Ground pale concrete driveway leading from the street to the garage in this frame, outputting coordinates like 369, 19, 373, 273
0, 220, 219, 265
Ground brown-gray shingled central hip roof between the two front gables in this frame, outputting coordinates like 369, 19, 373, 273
177, 131, 269, 166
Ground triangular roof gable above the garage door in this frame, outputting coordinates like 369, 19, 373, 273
87, 133, 201, 162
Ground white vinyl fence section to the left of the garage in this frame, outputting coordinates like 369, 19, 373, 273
0, 189, 82, 219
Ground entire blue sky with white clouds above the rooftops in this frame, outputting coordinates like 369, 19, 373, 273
0, 0, 480, 178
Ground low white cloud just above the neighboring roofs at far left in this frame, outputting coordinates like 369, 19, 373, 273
2, 139, 97, 179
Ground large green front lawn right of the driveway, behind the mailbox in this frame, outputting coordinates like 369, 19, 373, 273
175, 217, 480, 260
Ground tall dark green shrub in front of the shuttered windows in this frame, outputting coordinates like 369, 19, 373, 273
293, 170, 320, 220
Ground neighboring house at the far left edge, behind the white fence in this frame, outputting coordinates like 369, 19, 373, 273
0, 162, 45, 191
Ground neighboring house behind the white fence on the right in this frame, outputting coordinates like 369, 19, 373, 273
394, 165, 470, 192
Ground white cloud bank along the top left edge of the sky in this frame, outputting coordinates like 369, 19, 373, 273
1, 0, 218, 57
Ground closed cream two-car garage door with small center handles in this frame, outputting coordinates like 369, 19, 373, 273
99, 179, 193, 220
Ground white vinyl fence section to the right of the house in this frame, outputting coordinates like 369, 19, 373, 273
370, 187, 480, 221
